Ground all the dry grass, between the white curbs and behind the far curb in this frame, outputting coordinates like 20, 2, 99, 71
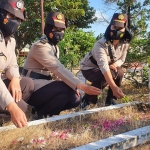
0, 80, 150, 150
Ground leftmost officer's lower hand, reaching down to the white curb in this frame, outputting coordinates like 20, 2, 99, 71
6, 102, 27, 128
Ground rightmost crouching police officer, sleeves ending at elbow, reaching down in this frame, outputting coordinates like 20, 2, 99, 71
80, 13, 131, 108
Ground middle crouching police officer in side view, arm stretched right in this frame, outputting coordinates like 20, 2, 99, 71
22, 12, 101, 118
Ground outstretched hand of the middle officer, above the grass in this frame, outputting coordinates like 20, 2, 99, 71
77, 82, 102, 95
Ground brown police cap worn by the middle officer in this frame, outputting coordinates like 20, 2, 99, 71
46, 12, 66, 29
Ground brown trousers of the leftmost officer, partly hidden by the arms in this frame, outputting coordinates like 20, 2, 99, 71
0, 77, 34, 112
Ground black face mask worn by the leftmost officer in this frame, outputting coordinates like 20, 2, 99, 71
2, 19, 20, 35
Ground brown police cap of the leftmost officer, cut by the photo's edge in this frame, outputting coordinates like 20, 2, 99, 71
0, 0, 25, 20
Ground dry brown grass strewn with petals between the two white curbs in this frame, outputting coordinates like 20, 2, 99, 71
0, 107, 150, 150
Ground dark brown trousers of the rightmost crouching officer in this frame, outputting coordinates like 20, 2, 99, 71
81, 67, 123, 104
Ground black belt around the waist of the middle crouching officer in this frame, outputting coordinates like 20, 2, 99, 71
22, 69, 52, 80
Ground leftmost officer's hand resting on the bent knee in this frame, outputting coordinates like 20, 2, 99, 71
8, 77, 22, 102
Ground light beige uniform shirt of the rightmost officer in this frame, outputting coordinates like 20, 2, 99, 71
80, 37, 129, 74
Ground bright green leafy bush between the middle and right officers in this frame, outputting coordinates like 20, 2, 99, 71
59, 29, 96, 70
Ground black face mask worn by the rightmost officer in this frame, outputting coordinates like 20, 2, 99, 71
110, 30, 125, 40
